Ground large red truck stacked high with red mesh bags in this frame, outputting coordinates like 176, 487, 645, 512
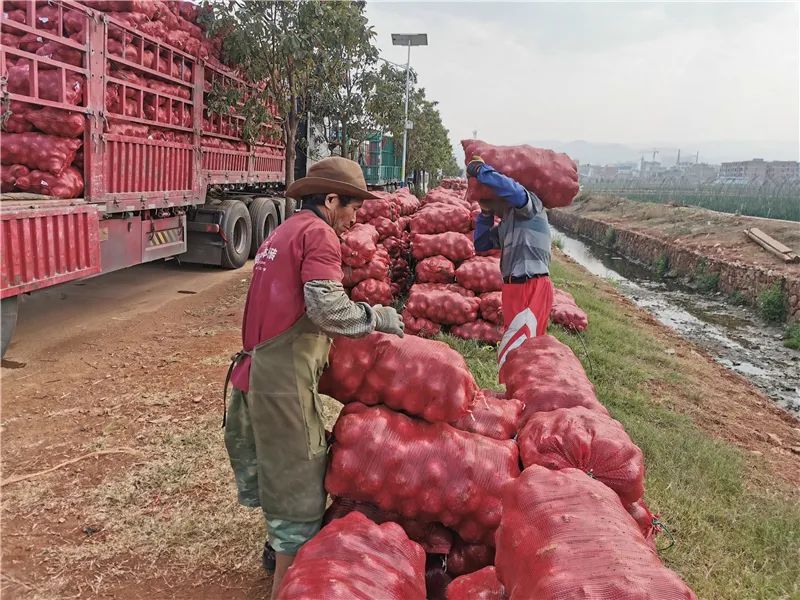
0, 0, 294, 354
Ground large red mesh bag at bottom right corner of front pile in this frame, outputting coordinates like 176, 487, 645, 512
495, 466, 696, 600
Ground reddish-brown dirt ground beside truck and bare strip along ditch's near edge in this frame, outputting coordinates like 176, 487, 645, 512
0, 255, 800, 600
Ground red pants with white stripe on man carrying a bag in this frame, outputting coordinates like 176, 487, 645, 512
497, 277, 553, 370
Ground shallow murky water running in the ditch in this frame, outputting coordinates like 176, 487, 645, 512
552, 227, 800, 417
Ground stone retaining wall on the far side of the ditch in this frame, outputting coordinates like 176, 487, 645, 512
548, 210, 800, 321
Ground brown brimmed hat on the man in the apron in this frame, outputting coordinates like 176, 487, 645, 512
286, 156, 379, 200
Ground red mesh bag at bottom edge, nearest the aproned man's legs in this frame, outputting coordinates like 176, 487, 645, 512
277, 512, 425, 600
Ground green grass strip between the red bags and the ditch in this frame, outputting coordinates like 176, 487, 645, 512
438, 261, 800, 600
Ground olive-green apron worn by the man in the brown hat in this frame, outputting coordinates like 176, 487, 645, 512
228, 314, 331, 522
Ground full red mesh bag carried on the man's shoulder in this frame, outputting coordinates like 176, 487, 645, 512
461, 140, 578, 208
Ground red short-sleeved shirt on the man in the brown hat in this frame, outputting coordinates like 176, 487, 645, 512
231, 210, 342, 392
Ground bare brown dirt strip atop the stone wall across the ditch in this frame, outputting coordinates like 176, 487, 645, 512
561, 194, 800, 278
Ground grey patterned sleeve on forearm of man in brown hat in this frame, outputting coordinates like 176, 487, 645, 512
303, 279, 377, 337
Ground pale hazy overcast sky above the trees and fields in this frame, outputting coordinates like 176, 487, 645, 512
367, 0, 800, 161
